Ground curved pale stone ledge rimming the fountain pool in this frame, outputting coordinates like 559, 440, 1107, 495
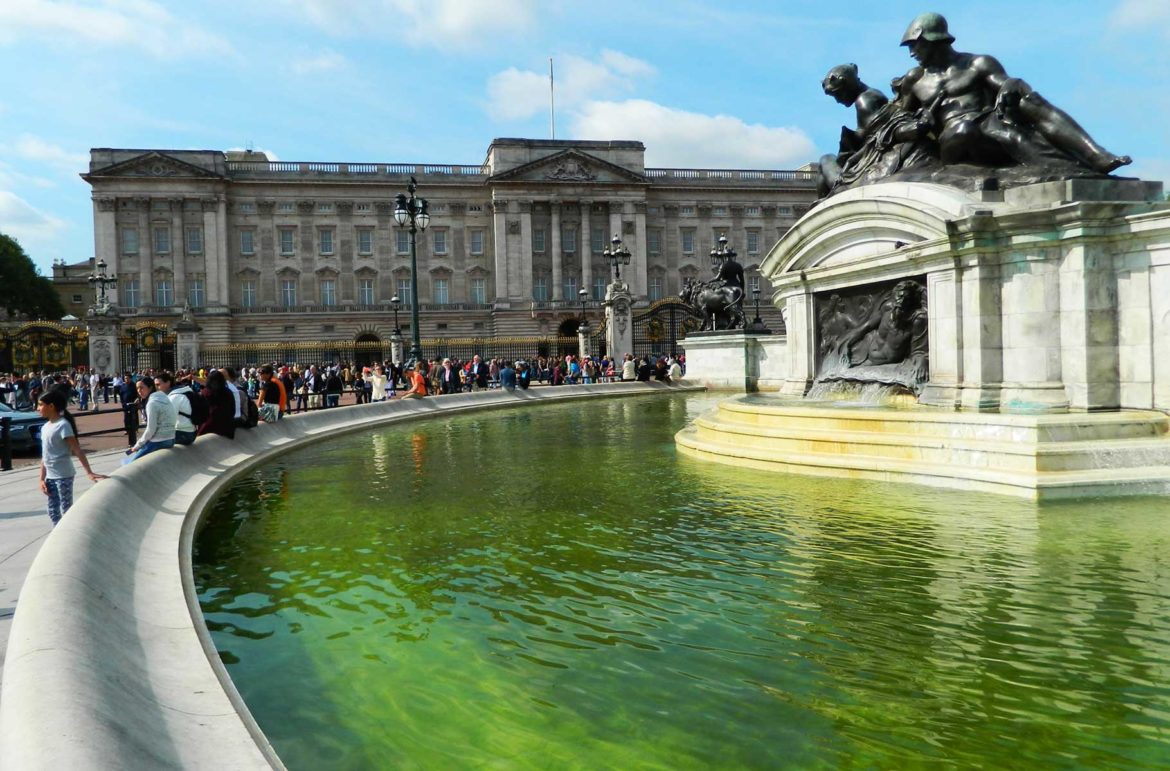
0, 383, 702, 771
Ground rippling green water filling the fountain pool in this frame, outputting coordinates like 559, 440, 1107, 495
195, 395, 1170, 770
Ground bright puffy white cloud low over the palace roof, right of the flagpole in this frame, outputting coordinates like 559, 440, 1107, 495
570, 99, 817, 168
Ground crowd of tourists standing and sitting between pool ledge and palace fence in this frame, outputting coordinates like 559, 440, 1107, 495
9, 353, 684, 525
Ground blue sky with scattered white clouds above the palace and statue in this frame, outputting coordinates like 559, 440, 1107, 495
0, 0, 1170, 274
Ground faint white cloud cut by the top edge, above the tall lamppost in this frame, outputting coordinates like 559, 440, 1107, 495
282, 0, 537, 49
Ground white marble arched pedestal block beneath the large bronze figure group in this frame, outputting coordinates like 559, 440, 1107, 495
758, 179, 1170, 414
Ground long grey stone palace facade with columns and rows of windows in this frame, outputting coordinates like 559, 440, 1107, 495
82, 139, 815, 343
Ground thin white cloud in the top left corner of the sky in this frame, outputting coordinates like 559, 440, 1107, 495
0, 0, 232, 58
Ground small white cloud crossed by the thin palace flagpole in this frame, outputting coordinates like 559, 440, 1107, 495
487, 50, 654, 119
